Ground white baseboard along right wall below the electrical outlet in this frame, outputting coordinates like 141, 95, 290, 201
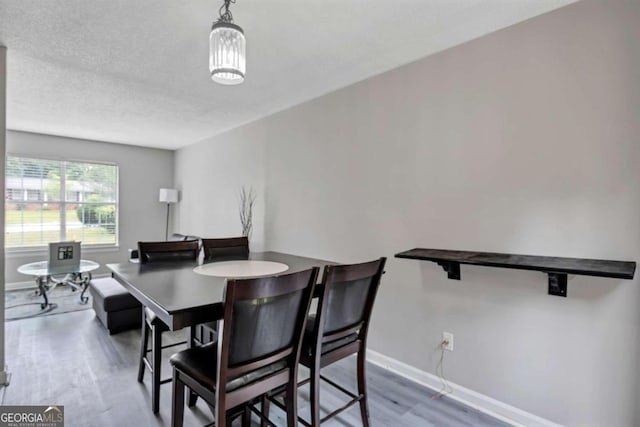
367, 349, 561, 427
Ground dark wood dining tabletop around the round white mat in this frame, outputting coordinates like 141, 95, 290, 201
107, 252, 335, 330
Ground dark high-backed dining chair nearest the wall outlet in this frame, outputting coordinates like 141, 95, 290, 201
262, 257, 386, 427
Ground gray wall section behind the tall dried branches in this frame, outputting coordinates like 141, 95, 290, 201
175, 123, 265, 251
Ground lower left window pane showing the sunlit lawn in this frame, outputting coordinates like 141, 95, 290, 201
5, 202, 60, 248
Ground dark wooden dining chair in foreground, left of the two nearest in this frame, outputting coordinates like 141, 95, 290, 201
170, 267, 318, 427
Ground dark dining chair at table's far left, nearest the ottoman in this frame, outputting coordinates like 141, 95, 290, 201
138, 240, 200, 413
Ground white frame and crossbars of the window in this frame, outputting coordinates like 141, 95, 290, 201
4, 153, 120, 252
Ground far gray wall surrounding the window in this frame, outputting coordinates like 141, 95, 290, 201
6, 131, 174, 283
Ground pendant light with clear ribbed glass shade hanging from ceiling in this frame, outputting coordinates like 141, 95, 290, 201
209, 0, 246, 85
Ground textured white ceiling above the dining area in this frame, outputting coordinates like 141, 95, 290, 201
0, 0, 575, 149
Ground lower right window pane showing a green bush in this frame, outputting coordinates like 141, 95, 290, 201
66, 203, 117, 244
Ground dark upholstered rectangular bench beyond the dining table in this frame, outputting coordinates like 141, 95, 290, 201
89, 277, 142, 334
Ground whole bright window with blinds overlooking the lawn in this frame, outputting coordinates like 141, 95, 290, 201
5, 156, 118, 248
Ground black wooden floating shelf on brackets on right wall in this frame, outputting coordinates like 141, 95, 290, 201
396, 248, 636, 297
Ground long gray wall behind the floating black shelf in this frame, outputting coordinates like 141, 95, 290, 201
176, 0, 640, 426
